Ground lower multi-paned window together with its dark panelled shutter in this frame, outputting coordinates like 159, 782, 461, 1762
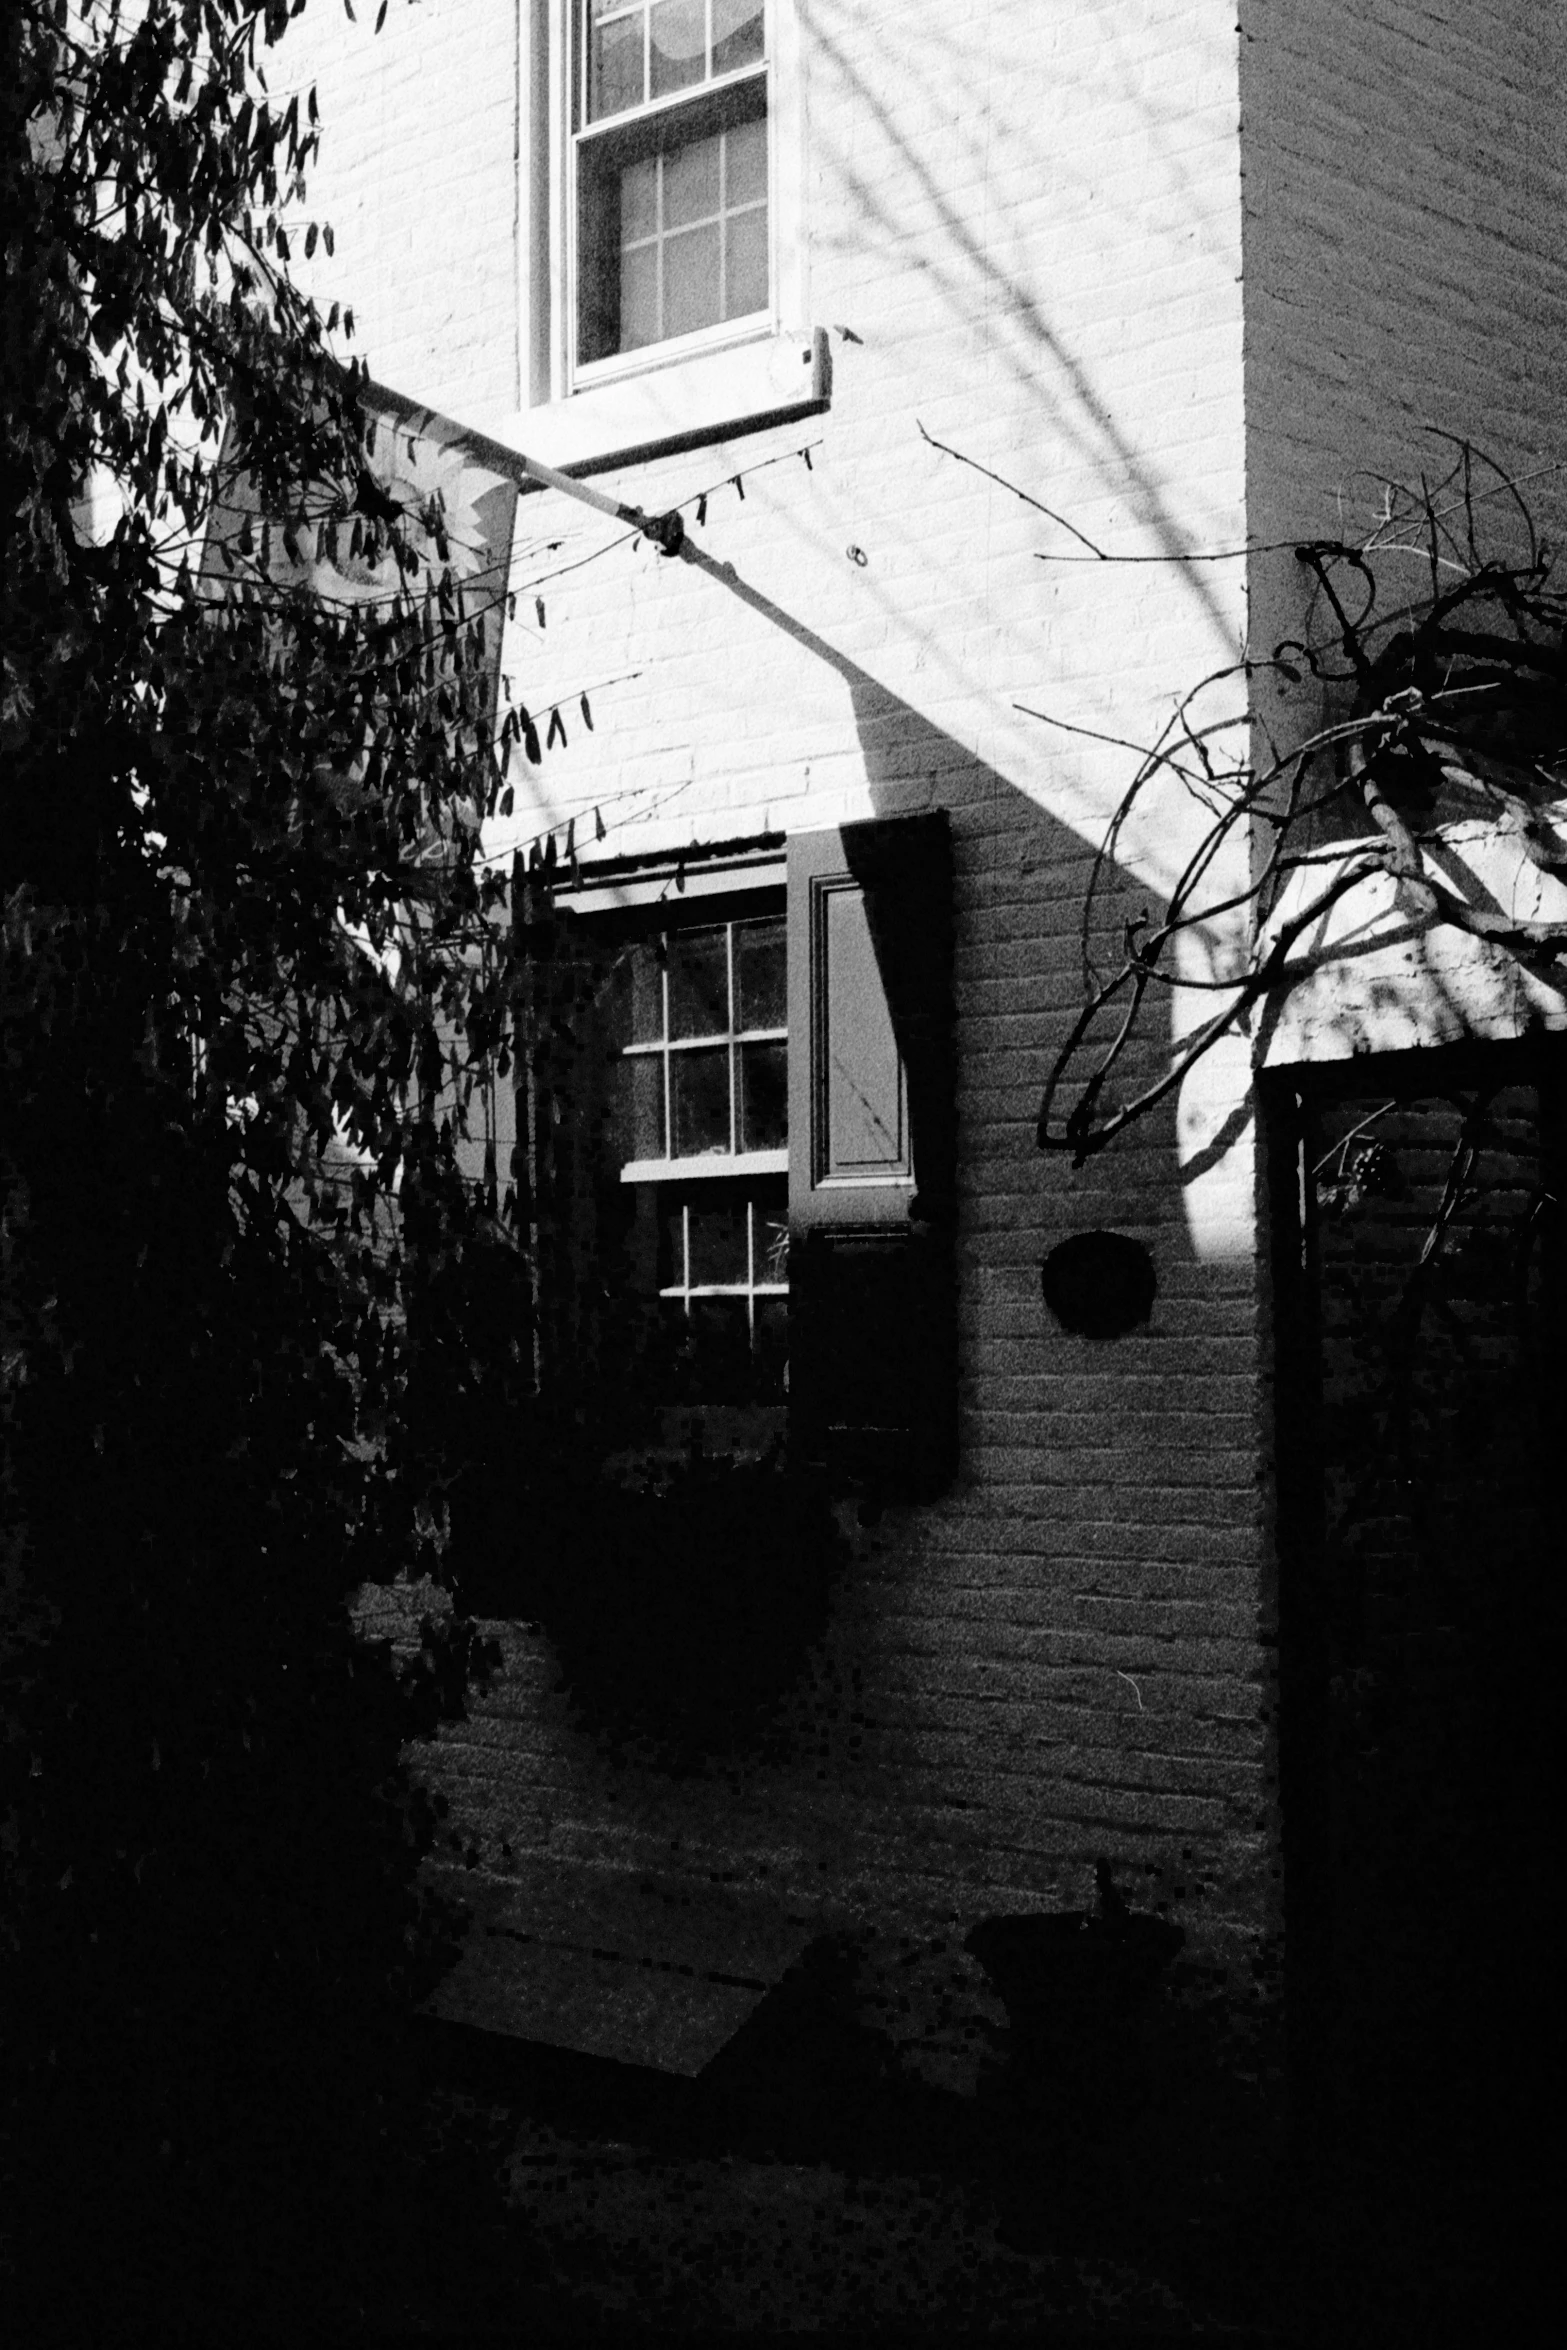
524, 818, 956, 1492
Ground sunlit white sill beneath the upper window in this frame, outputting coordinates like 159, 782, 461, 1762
472, 327, 832, 472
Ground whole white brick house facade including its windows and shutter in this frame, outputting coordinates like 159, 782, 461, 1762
275, 0, 1565, 2070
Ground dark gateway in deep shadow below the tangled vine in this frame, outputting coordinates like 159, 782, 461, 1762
1266, 1039, 1567, 2174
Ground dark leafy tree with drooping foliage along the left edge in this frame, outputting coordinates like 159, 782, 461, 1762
0, 0, 533, 2331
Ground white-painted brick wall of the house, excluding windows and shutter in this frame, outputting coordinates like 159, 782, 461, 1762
294, 0, 1562, 1983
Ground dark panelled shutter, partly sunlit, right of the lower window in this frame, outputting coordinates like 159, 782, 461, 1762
789, 815, 956, 1495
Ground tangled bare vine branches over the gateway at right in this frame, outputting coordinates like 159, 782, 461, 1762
958, 435, 1567, 1166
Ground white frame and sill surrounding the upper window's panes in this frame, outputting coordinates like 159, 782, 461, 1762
514, 0, 829, 470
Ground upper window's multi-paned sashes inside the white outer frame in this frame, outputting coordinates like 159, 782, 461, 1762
573, 0, 773, 367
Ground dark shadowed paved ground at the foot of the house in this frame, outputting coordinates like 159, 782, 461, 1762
408, 2035, 1551, 2350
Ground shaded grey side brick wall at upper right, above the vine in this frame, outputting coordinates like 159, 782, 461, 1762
1240, 0, 1567, 752
